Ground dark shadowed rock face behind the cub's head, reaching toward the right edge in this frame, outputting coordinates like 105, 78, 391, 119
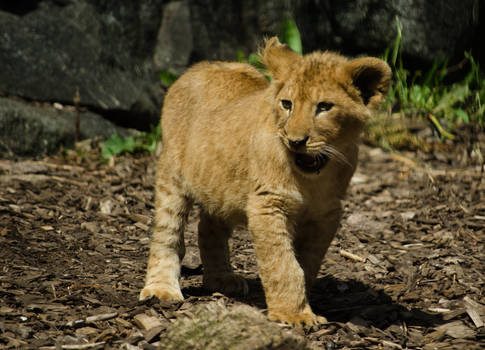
185, 0, 485, 65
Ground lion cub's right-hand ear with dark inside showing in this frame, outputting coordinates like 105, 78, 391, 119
345, 57, 392, 109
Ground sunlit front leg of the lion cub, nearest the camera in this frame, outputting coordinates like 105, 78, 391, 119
248, 197, 325, 327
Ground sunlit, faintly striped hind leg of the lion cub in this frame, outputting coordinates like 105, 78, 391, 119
140, 176, 190, 301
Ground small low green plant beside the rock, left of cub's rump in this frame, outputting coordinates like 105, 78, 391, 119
101, 125, 162, 160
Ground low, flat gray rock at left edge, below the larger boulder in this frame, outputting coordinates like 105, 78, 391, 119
0, 98, 132, 157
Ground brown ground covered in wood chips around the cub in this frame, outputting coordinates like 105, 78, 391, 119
0, 140, 485, 349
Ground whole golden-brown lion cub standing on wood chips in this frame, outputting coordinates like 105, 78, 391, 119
140, 38, 391, 326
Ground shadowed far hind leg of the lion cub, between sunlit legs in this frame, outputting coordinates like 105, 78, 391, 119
199, 211, 248, 296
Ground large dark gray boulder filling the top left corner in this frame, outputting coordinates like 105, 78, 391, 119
0, 0, 162, 127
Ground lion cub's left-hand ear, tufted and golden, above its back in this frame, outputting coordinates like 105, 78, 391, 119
259, 36, 302, 80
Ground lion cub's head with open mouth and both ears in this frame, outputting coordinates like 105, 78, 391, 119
261, 37, 391, 176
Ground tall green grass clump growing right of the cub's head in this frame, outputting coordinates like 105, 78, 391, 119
383, 18, 485, 139
